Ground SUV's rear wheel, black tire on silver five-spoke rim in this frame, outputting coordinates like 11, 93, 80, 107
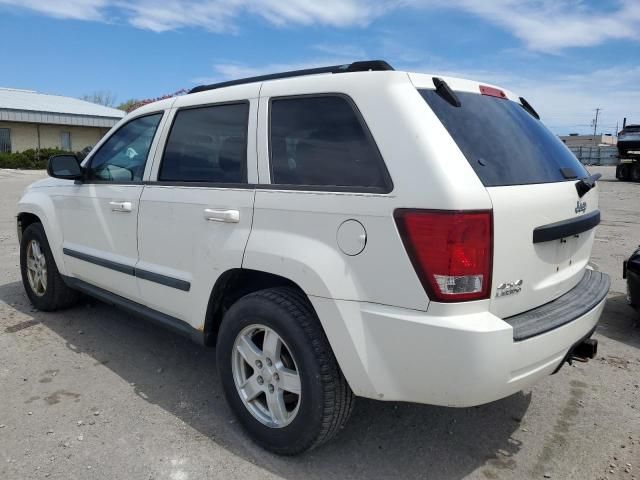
216, 287, 354, 455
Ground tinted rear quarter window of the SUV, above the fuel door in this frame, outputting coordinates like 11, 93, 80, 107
270, 95, 391, 192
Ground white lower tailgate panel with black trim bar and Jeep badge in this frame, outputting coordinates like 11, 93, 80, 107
487, 182, 599, 318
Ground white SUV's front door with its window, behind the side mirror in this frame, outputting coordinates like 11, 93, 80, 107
54, 113, 163, 300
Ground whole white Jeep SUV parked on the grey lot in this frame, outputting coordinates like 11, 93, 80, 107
18, 61, 609, 454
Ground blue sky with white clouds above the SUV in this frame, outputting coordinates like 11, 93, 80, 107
0, 0, 640, 133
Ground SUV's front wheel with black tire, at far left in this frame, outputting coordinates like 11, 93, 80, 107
20, 223, 79, 312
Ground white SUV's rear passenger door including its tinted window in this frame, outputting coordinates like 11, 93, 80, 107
136, 85, 258, 328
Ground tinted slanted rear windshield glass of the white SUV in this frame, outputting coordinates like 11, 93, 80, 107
420, 90, 588, 187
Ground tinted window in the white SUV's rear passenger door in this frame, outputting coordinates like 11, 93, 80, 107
158, 102, 249, 183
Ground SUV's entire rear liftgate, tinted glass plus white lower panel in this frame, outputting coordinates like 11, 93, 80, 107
420, 87, 599, 318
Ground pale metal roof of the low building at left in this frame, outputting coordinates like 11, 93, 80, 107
0, 87, 125, 127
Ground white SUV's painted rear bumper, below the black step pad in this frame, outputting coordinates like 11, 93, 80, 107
312, 272, 605, 407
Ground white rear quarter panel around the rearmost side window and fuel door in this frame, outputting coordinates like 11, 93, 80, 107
243, 72, 491, 310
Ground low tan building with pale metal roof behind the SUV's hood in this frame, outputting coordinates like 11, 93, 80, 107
0, 88, 125, 152
